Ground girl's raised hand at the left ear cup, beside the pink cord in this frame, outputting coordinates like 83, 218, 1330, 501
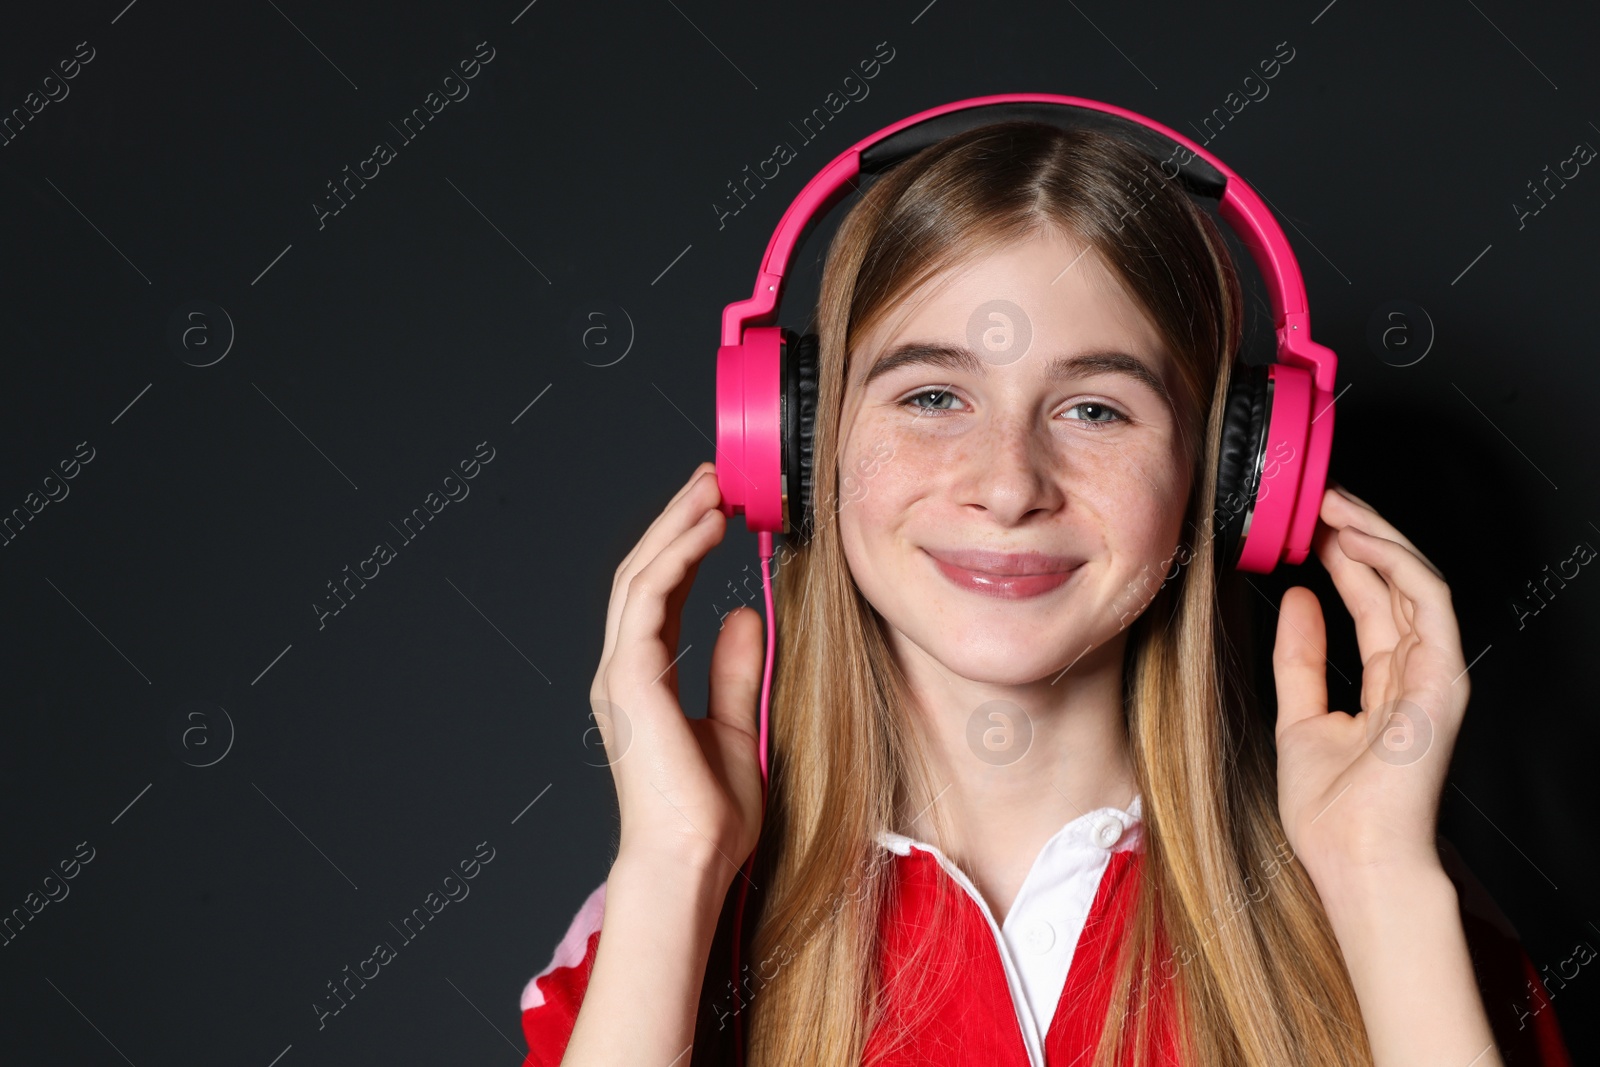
589, 462, 765, 885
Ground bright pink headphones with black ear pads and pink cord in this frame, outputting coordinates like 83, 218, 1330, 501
717, 93, 1338, 1064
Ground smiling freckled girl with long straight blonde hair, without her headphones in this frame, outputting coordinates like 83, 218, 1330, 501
523, 122, 1566, 1067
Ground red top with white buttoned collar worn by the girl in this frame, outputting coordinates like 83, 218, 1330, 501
522, 798, 1571, 1067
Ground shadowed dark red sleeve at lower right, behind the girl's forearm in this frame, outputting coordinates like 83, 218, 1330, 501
1438, 838, 1571, 1067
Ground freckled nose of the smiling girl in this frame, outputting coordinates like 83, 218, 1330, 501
957, 411, 1066, 526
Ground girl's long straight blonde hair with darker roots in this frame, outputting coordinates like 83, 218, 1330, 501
694, 122, 1371, 1067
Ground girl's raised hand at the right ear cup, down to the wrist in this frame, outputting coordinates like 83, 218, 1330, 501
1272, 488, 1470, 897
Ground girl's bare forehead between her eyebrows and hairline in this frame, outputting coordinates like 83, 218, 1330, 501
851, 232, 1166, 381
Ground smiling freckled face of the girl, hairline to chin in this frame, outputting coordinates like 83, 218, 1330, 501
838, 235, 1190, 685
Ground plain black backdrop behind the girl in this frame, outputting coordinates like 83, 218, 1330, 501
0, 0, 1600, 1067
